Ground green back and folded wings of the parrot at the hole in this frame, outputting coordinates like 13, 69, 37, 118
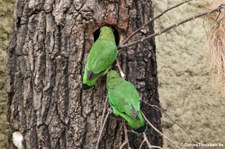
86, 39, 118, 74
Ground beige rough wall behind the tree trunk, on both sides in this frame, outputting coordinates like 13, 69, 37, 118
0, 0, 225, 149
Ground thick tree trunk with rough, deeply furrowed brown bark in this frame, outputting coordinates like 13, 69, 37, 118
7, 0, 162, 149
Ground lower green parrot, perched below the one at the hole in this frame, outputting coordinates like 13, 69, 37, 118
107, 70, 146, 133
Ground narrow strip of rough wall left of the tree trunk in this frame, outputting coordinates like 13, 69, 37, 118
0, 0, 14, 149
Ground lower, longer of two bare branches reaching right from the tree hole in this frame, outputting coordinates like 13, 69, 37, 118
119, 5, 224, 48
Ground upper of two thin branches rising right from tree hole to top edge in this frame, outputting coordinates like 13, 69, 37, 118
122, 0, 192, 45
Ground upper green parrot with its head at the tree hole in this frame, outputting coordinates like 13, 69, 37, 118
82, 26, 118, 90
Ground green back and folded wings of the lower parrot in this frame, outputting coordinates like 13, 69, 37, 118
108, 80, 140, 119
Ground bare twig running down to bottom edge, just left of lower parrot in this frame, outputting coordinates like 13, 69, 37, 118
95, 98, 110, 149
